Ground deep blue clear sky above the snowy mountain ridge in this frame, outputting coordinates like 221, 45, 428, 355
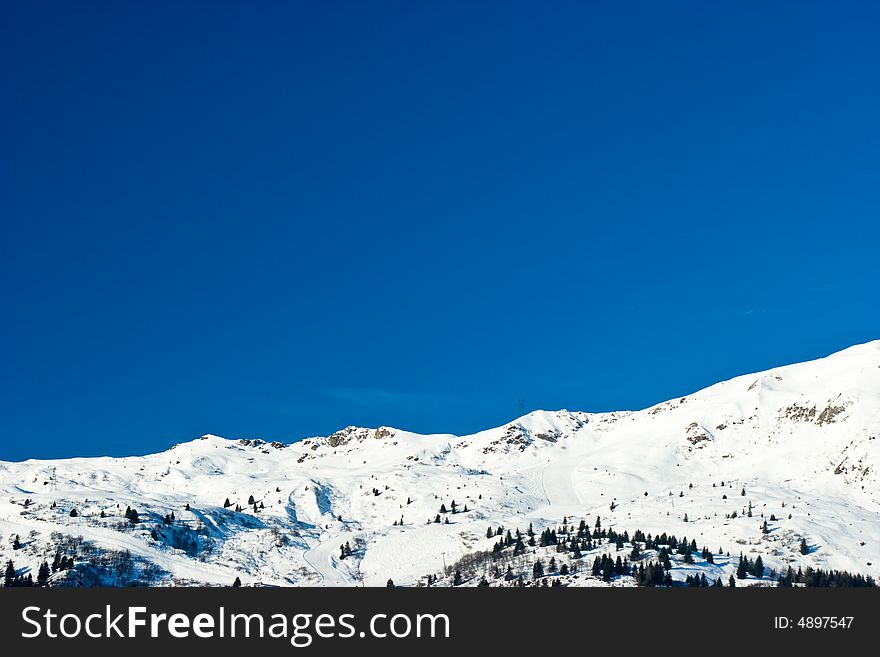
0, 1, 880, 460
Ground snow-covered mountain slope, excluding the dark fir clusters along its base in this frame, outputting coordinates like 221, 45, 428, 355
0, 341, 880, 585
